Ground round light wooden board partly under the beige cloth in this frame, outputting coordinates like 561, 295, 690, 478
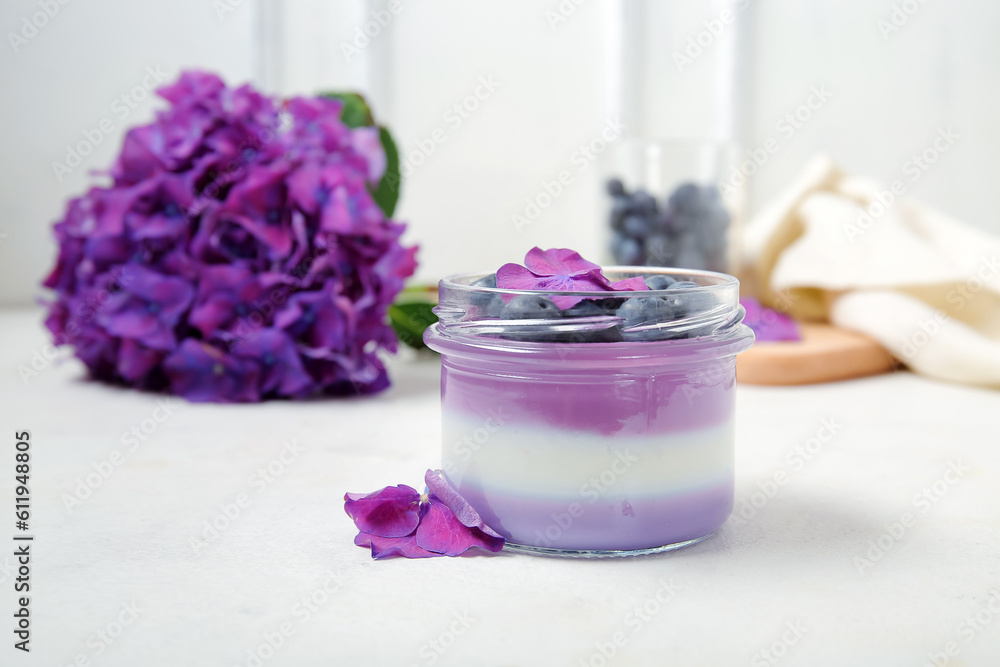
736, 324, 896, 385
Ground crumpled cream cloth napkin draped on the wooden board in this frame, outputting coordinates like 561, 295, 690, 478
745, 156, 1000, 387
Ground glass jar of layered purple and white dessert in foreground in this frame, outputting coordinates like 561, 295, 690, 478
424, 267, 753, 557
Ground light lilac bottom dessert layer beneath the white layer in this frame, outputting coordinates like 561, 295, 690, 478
459, 480, 733, 551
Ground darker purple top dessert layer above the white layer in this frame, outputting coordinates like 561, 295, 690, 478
441, 356, 736, 435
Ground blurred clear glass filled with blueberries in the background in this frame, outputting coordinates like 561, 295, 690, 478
604, 139, 744, 275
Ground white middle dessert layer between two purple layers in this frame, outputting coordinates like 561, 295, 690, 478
443, 413, 733, 499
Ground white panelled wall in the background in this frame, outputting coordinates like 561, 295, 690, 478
0, 0, 1000, 304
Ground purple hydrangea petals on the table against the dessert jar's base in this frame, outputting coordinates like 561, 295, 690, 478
344, 470, 504, 559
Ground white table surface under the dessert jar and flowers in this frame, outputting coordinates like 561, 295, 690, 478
0, 311, 1000, 667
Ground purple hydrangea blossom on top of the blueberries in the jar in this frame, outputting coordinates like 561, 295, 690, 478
497, 247, 647, 308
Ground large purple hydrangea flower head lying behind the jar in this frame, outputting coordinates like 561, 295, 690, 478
44, 71, 416, 402
